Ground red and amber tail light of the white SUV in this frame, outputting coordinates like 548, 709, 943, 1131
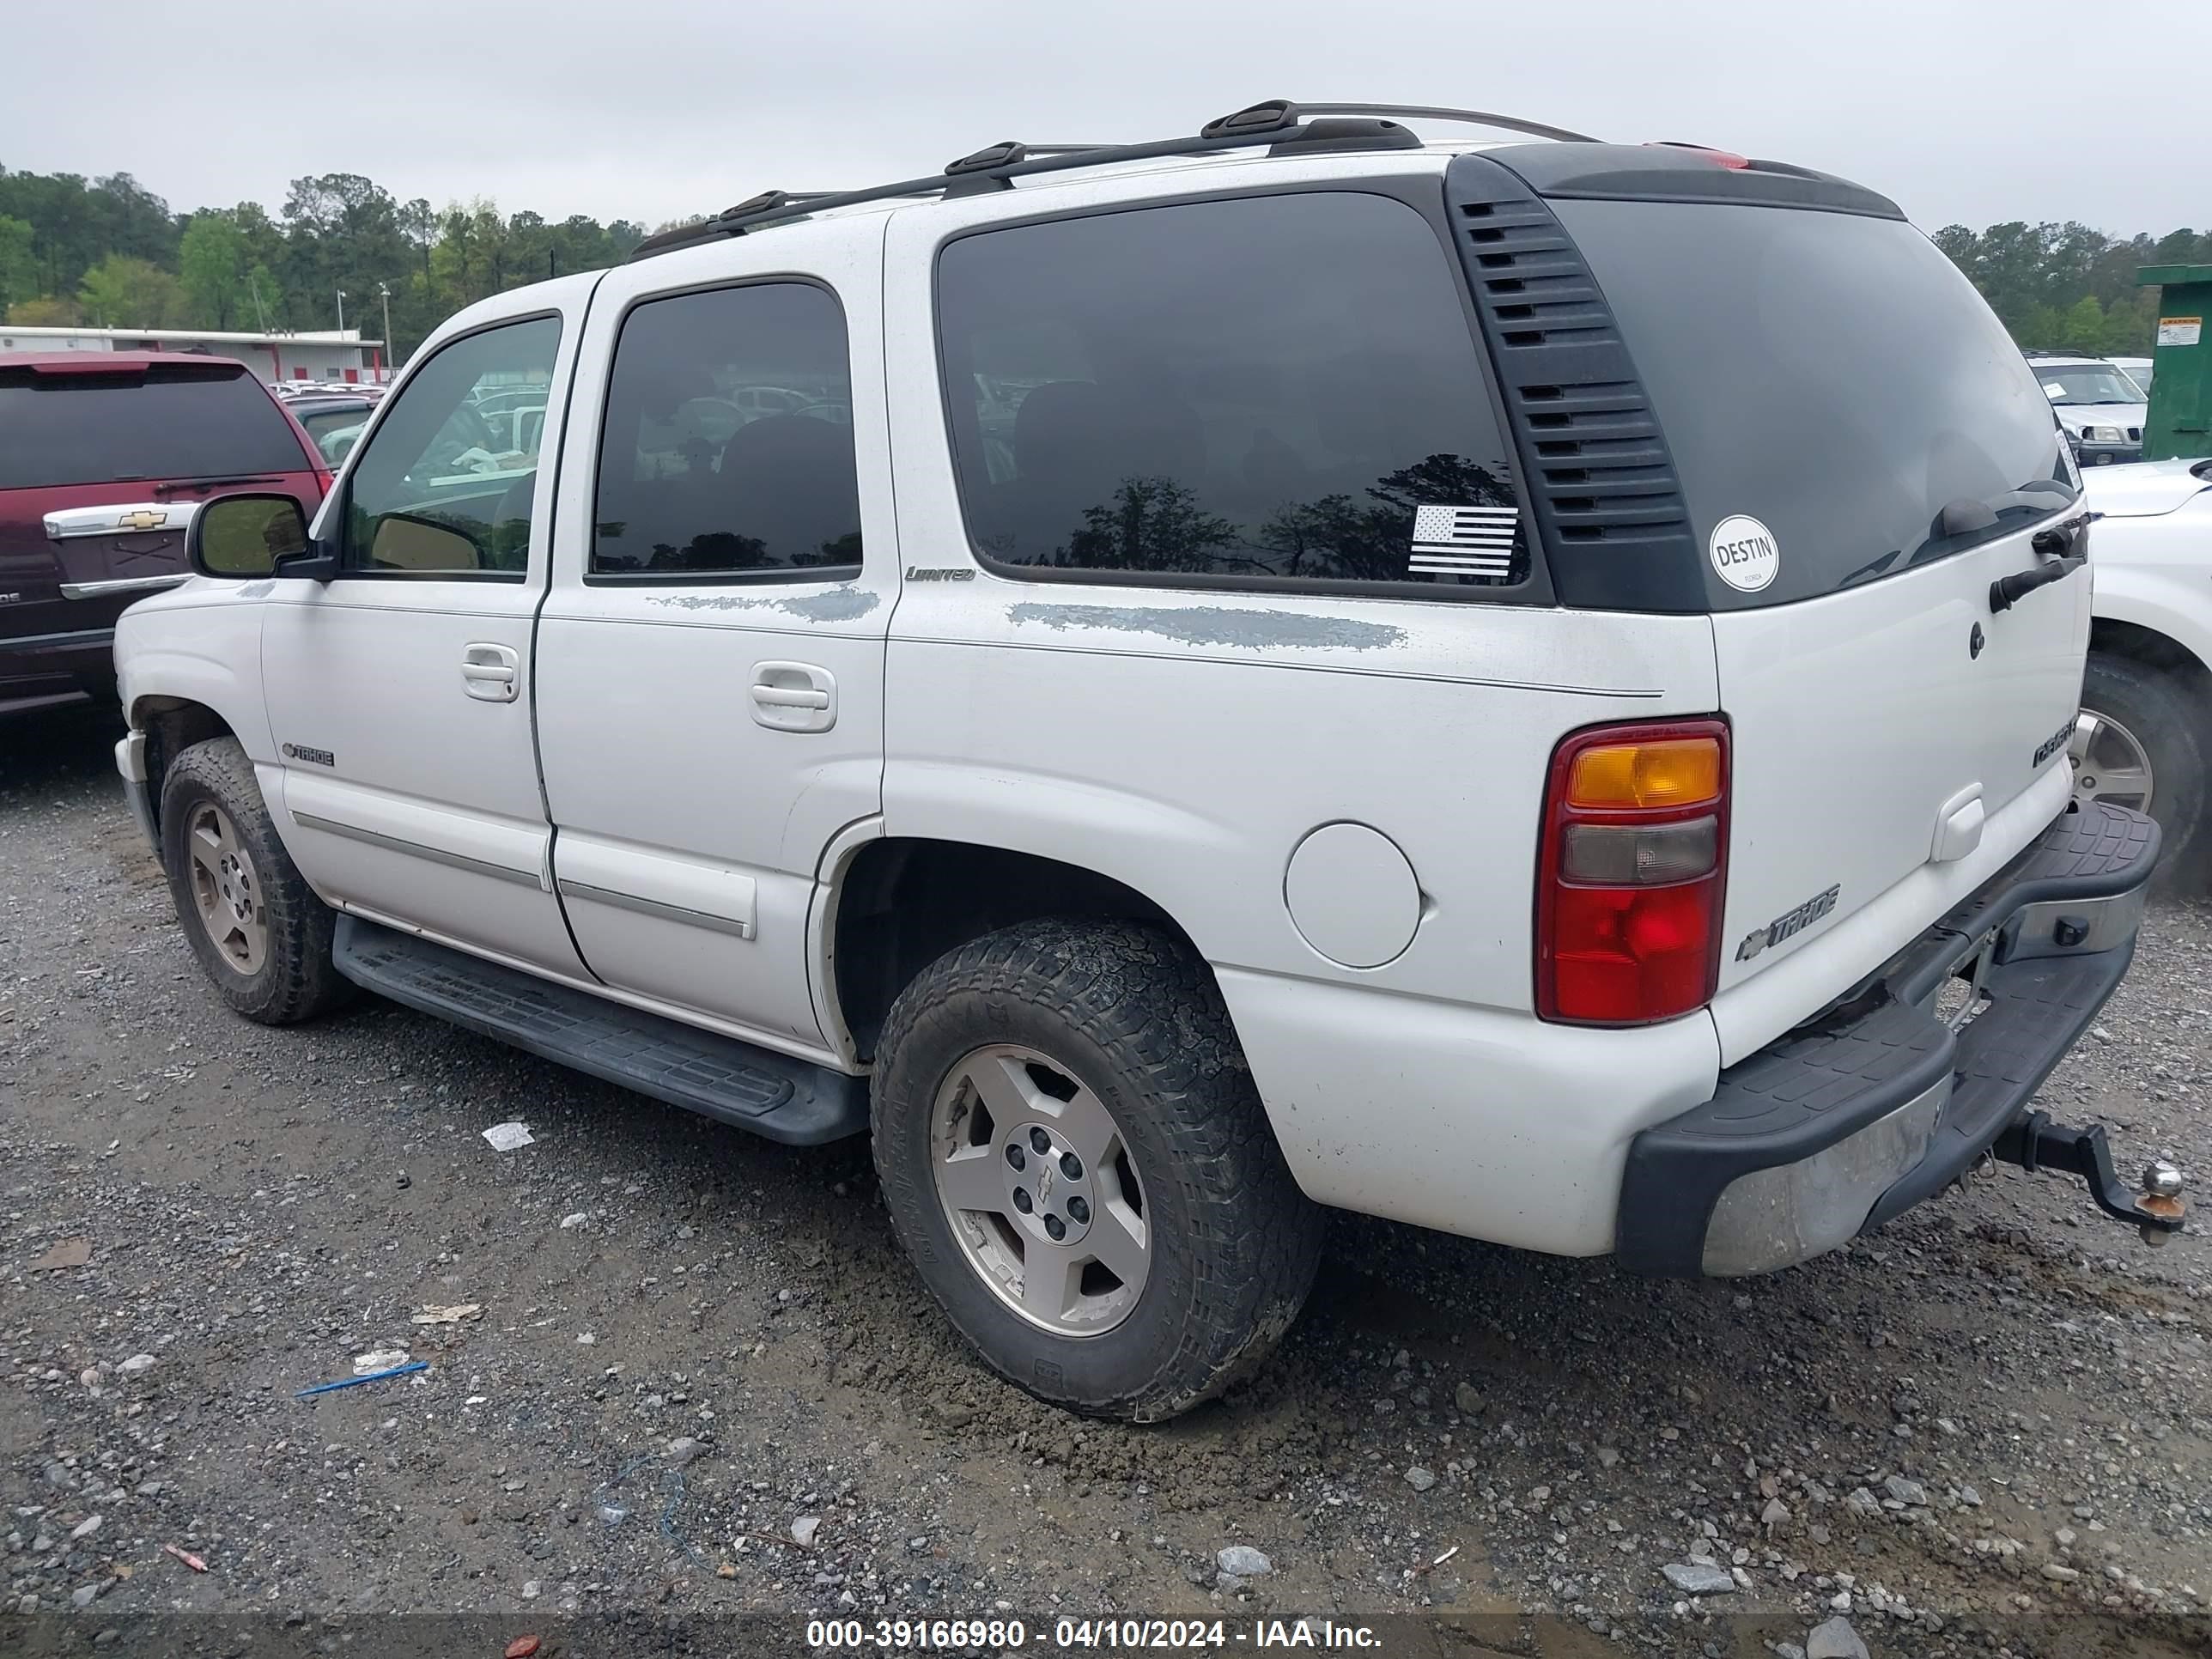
1535, 721, 1728, 1026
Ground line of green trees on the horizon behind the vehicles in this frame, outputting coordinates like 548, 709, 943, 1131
0, 168, 2212, 361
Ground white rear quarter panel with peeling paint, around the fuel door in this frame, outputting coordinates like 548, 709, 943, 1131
883, 157, 1719, 1252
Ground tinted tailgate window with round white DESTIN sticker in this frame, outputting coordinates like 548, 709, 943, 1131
1553, 201, 2073, 606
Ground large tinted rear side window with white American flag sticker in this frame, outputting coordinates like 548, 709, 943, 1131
938, 192, 1526, 586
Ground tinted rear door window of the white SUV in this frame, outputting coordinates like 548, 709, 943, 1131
591, 283, 860, 575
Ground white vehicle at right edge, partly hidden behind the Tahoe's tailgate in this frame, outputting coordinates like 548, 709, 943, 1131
2069, 460, 2212, 887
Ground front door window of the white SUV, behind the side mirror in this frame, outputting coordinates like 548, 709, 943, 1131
341, 316, 560, 581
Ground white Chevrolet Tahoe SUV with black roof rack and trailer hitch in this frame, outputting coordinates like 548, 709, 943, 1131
118, 104, 2179, 1420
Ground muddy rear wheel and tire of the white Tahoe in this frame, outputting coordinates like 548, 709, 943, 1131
874, 921, 1322, 1422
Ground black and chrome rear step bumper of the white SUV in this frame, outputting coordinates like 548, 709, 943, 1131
1614, 803, 2159, 1276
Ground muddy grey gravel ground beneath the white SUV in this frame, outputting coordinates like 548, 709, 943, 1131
0, 714, 2212, 1659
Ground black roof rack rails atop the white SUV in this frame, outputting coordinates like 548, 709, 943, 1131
630, 97, 1597, 261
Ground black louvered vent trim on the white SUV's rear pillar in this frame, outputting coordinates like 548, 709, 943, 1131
1444, 155, 1704, 611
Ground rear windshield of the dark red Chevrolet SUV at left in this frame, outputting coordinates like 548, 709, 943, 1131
0, 368, 307, 489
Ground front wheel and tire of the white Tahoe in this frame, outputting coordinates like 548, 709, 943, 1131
161, 737, 347, 1026
